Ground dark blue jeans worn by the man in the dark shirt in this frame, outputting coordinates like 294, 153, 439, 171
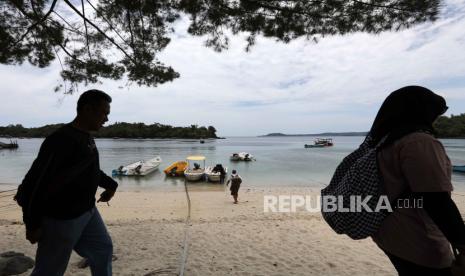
31, 207, 113, 276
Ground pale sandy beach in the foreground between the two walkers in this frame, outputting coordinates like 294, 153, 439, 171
0, 187, 465, 275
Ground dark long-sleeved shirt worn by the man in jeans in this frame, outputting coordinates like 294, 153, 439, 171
22, 124, 118, 229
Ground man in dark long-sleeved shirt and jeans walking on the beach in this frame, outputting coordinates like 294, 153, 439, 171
15, 90, 118, 276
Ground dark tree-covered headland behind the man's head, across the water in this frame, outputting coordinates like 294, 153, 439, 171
0, 122, 218, 139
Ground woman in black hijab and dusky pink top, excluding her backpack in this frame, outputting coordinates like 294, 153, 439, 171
370, 86, 465, 276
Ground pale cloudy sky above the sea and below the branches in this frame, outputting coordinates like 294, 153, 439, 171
0, 0, 465, 136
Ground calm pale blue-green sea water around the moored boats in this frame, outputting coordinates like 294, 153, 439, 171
0, 137, 465, 190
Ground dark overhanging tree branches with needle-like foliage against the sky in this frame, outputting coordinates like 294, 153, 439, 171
0, 0, 440, 93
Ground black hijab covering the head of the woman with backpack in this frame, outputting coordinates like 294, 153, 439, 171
368, 86, 448, 146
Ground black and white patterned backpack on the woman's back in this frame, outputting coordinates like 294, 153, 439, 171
321, 135, 389, 240
